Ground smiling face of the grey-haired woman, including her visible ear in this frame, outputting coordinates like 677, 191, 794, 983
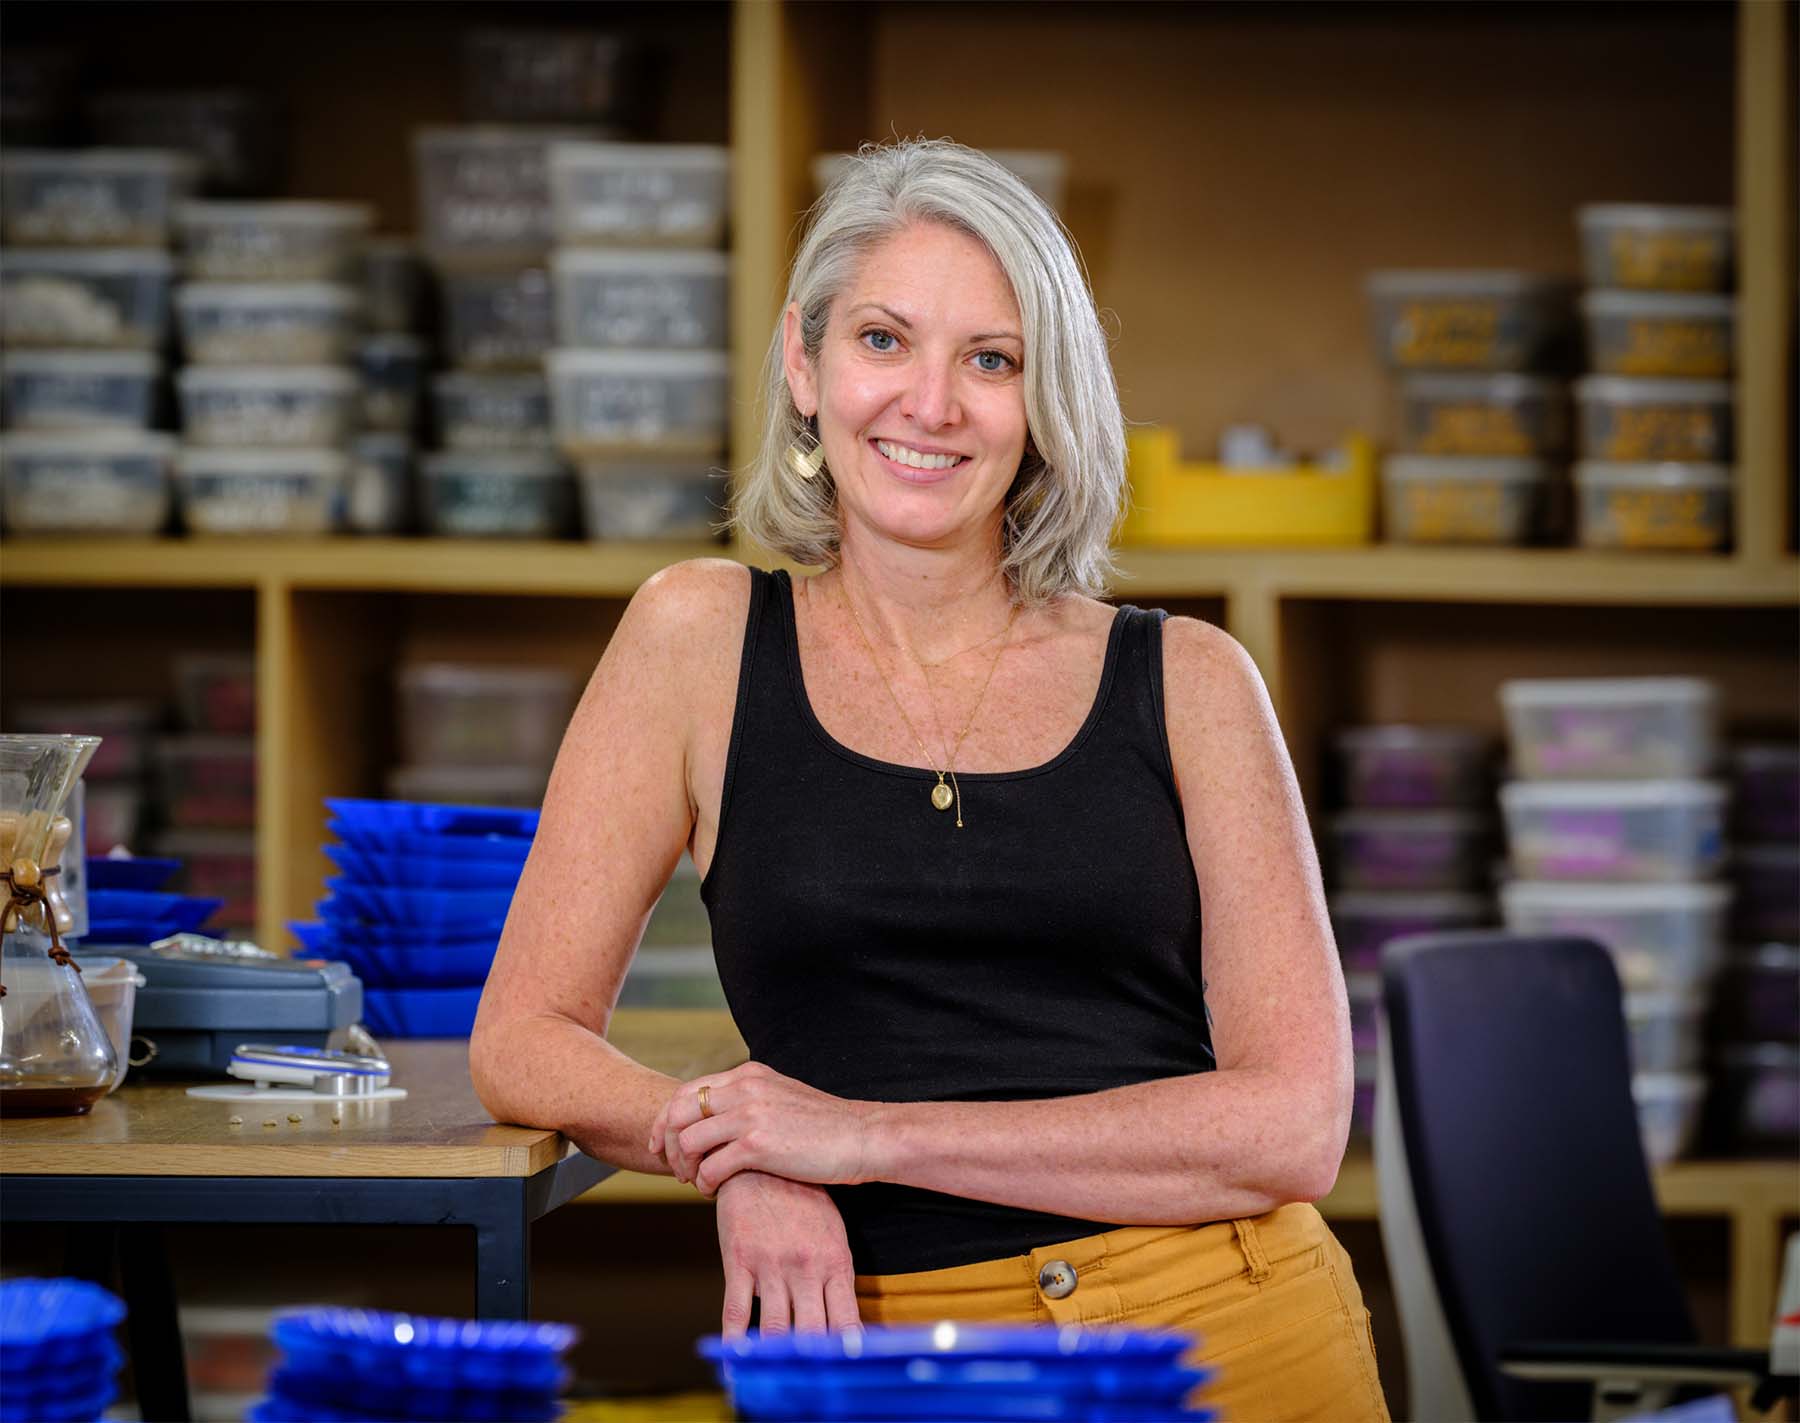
785, 223, 1026, 549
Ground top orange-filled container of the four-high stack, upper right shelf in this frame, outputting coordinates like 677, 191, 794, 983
1575, 203, 1737, 291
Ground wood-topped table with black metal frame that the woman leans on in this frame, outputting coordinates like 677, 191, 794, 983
0, 1009, 745, 1419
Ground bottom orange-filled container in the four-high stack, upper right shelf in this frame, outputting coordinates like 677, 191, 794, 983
1575, 462, 1733, 552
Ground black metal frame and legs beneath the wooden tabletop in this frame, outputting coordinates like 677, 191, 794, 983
0, 1151, 614, 1423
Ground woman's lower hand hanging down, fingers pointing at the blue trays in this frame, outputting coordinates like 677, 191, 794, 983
718, 1171, 862, 1338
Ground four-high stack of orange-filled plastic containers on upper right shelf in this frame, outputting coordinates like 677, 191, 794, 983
1575, 203, 1737, 552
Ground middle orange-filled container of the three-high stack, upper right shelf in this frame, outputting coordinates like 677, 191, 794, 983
1400, 372, 1570, 457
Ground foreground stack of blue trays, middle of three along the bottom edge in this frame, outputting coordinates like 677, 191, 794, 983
248, 1308, 576, 1423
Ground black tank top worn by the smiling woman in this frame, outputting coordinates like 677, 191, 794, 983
700, 570, 1213, 1274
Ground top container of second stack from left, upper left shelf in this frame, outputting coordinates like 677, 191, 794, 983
175, 201, 373, 282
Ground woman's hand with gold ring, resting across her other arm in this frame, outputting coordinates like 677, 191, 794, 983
650, 1061, 875, 1195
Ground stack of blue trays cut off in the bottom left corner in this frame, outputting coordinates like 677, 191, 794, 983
0, 1279, 124, 1423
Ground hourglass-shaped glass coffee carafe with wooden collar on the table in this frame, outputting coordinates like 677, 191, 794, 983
0, 736, 119, 1117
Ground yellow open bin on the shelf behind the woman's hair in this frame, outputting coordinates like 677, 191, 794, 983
1120, 426, 1375, 547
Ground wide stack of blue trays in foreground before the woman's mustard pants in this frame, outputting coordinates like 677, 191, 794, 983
700, 1324, 1213, 1423
